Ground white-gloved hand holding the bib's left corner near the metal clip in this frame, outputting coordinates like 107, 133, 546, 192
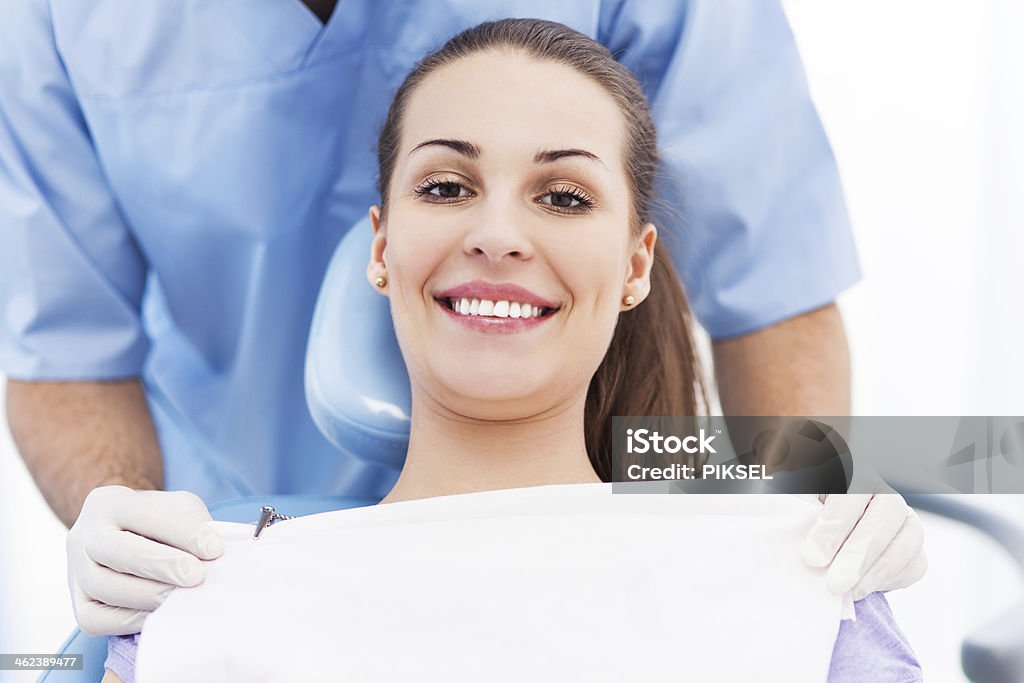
67, 486, 224, 636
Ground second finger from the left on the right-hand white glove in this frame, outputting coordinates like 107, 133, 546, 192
825, 494, 910, 593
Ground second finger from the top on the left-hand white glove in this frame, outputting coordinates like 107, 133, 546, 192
85, 526, 206, 587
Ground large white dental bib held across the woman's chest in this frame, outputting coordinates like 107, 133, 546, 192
136, 484, 852, 683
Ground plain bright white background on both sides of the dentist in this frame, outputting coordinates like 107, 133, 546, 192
0, 0, 1024, 681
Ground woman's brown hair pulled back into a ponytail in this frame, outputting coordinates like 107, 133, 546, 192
377, 18, 708, 481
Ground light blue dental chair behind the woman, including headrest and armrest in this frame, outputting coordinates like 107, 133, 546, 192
39, 219, 1024, 683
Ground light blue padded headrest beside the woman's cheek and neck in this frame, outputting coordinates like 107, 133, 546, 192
305, 217, 412, 469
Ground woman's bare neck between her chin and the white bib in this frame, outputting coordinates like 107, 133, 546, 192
381, 389, 600, 503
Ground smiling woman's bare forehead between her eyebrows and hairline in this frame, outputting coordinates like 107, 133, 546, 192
399, 50, 625, 168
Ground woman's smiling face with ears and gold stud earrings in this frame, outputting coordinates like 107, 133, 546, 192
367, 51, 656, 420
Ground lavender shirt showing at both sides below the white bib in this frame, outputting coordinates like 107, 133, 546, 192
103, 593, 924, 683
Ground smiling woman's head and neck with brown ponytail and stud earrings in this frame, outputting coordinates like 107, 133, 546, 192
368, 20, 707, 500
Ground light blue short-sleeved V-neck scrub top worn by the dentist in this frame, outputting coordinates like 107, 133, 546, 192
0, 0, 859, 502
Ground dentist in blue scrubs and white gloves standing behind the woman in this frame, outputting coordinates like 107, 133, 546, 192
0, 0, 924, 634
